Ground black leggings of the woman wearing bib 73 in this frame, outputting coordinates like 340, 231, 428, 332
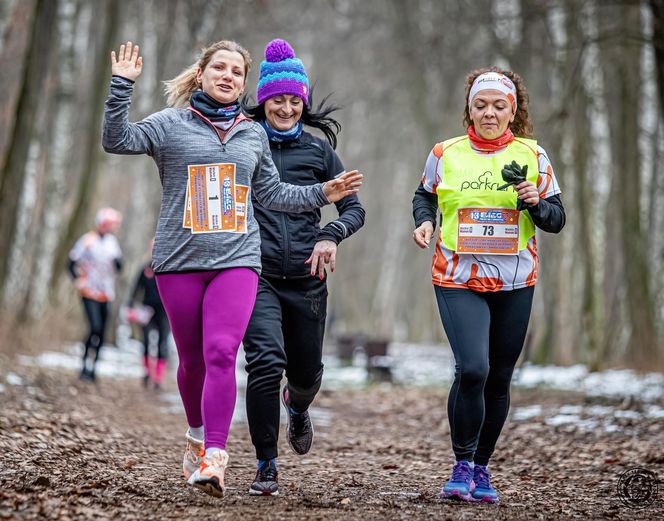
434, 286, 535, 465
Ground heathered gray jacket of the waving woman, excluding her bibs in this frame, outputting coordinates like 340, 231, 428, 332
102, 76, 329, 273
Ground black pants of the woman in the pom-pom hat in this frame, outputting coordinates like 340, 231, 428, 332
243, 277, 327, 460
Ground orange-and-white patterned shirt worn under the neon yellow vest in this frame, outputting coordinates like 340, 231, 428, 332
422, 141, 560, 291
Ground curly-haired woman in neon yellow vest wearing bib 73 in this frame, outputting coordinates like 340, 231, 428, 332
413, 67, 565, 503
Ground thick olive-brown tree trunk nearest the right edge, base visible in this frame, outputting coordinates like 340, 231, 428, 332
604, 4, 657, 369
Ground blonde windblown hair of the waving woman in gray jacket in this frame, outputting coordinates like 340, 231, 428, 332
164, 40, 251, 107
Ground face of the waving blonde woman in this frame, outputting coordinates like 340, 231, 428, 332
196, 50, 247, 103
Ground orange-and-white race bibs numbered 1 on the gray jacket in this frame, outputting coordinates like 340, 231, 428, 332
182, 163, 249, 233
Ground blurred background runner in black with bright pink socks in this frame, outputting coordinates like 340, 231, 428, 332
127, 241, 171, 390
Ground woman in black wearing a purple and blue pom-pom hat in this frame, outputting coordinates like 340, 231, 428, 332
243, 39, 364, 496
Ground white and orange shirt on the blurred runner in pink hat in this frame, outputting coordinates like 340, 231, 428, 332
69, 231, 122, 302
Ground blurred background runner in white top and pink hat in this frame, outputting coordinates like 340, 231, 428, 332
69, 208, 122, 381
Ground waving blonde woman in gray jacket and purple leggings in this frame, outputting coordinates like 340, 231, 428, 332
102, 41, 361, 496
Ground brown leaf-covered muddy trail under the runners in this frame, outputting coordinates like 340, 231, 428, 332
0, 360, 664, 520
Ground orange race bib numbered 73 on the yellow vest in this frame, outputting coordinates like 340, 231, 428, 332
456, 208, 519, 255
